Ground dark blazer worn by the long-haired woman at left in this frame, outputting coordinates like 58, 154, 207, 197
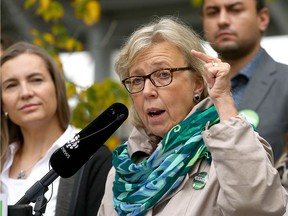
55, 146, 112, 216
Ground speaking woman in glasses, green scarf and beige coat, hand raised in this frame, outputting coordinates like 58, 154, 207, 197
98, 17, 287, 216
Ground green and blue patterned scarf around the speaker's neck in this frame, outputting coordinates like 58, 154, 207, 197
113, 106, 219, 216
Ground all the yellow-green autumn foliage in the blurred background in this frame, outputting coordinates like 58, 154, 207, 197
24, 0, 128, 150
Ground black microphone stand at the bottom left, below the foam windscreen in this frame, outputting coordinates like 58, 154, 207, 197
8, 169, 59, 216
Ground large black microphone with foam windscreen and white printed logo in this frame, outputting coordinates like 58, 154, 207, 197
16, 103, 128, 205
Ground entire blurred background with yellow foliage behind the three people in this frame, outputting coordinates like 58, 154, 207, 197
1, 0, 288, 148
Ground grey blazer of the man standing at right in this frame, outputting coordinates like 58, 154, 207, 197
239, 48, 288, 161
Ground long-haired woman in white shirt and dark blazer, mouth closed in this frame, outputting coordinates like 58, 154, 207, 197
0, 42, 111, 216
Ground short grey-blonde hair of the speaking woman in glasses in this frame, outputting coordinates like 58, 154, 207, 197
115, 16, 207, 127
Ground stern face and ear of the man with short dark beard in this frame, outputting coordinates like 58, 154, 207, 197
202, 0, 269, 59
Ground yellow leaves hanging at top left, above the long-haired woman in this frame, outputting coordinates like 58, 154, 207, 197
24, 0, 101, 57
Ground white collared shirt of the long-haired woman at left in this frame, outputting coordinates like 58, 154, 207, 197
0, 126, 76, 216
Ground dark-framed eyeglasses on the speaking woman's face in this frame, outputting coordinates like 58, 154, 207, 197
122, 67, 192, 94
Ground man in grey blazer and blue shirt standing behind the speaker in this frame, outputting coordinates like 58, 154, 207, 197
202, 0, 288, 161
